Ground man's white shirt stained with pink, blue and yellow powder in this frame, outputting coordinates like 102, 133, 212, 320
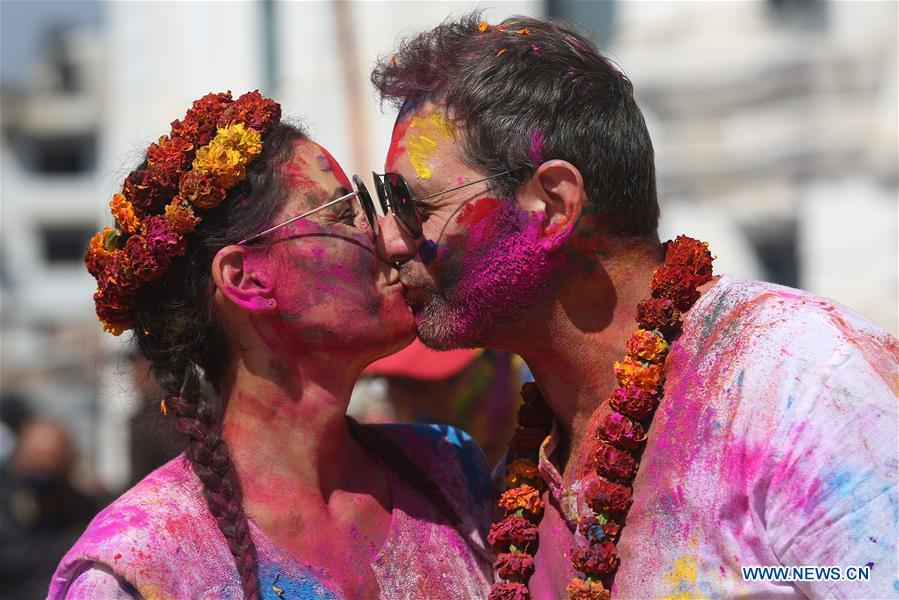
532, 276, 899, 598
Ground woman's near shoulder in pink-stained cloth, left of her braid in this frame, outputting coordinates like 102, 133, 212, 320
48, 455, 239, 598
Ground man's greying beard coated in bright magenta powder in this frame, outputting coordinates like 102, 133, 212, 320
414, 207, 560, 350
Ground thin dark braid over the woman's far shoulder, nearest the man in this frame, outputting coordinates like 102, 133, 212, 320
347, 416, 493, 562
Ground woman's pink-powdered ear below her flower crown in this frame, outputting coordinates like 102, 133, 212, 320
212, 245, 277, 312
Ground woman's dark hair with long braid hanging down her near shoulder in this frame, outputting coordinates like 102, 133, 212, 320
134, 123, 308, 598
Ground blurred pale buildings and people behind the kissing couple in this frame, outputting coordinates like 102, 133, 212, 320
0, 0, 899, 598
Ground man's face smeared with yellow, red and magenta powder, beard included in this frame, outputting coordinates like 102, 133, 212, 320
379, 102, 553, 349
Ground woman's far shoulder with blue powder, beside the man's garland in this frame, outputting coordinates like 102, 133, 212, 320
366, 423, 492, 507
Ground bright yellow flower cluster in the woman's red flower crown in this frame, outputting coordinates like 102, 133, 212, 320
193, 123, 262, 188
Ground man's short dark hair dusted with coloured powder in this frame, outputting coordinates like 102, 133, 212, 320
371, 12, 659, 236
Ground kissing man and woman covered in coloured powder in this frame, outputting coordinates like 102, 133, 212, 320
48, 14, 899, 600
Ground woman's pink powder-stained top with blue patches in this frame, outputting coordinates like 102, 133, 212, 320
48, 425, 492, 600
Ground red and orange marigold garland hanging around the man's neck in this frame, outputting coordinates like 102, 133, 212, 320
487, 236, 713, 600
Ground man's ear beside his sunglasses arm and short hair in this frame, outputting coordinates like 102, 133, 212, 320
531, 160, 587, 251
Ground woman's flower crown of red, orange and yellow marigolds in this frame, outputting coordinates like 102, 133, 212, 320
84, 91, 281, 335
